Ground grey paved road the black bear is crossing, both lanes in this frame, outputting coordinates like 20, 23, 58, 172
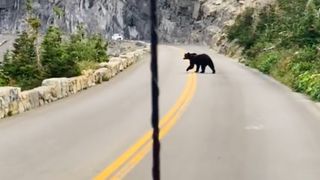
0, 46, 320, 180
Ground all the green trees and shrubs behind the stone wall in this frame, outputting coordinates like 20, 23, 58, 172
0, 23, 108, 90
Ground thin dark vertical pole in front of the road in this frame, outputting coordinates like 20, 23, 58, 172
150, 0, 160, 180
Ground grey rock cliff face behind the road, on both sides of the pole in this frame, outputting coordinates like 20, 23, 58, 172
0, 0, 272, 44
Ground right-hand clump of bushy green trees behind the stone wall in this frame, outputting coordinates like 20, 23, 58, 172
42, 27, 108, 77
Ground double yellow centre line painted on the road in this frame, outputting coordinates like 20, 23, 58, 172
94, 73, 197, 180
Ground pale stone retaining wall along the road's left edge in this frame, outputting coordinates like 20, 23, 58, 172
0, 48, 149, 118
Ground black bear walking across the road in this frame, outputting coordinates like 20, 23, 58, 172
183, 53, 216, 74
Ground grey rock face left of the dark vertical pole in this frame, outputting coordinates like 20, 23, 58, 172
0, 0, 149, 39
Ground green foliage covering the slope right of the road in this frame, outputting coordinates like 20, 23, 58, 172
228, 0, 320, 101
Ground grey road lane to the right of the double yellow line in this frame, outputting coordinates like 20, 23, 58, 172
125, 46, 320, 180
